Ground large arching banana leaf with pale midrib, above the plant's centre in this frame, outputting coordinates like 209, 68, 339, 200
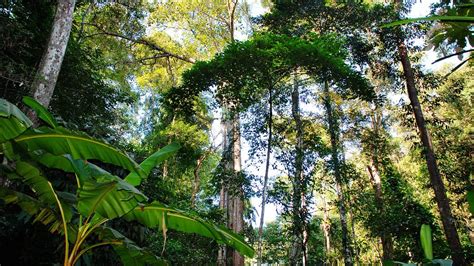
15, 127, 144, 177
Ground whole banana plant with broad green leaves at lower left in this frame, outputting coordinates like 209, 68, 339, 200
0, 97, 254, 265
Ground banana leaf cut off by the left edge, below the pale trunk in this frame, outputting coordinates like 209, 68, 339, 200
0, 99, 33, 142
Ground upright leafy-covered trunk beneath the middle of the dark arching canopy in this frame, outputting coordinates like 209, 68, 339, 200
290, 73, 306, 265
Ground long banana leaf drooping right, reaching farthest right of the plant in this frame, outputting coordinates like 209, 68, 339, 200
124, 202, 255, 257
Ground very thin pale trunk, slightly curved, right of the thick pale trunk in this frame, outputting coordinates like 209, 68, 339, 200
257, 87, 273, 266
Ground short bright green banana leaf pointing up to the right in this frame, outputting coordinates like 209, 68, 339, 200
125, 143, 181, 186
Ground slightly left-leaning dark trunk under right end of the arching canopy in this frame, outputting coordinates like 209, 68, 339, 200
324, 82, 352, 265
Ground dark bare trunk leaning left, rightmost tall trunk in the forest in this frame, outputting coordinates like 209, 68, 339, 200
398, 38, 466, 265
